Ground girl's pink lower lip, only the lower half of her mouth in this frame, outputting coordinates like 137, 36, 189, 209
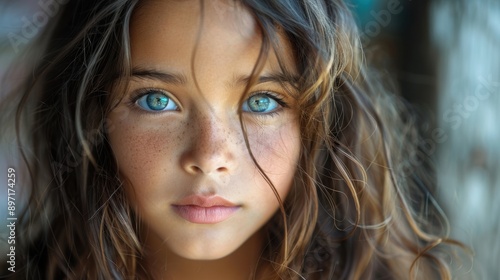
173, 205, 239, 224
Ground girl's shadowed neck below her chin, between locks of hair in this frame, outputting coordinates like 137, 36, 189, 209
143, 230, 275, 280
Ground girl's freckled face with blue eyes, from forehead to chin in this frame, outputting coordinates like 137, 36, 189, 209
109, 1, 300, 260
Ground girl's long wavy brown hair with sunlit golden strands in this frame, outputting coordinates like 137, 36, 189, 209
2, 0, 464, 279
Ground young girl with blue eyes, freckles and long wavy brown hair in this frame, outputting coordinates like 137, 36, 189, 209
3, 0, 466, 280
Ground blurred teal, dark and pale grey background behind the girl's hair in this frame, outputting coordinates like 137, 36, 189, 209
0, 0, 500, 279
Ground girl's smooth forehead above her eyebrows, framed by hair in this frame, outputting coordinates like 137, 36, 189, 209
131, 0, 261, 64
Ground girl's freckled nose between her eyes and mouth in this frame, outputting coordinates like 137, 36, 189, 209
180, 113, 239, 175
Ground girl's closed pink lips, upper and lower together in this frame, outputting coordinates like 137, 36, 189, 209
172, 195, 240, 224
